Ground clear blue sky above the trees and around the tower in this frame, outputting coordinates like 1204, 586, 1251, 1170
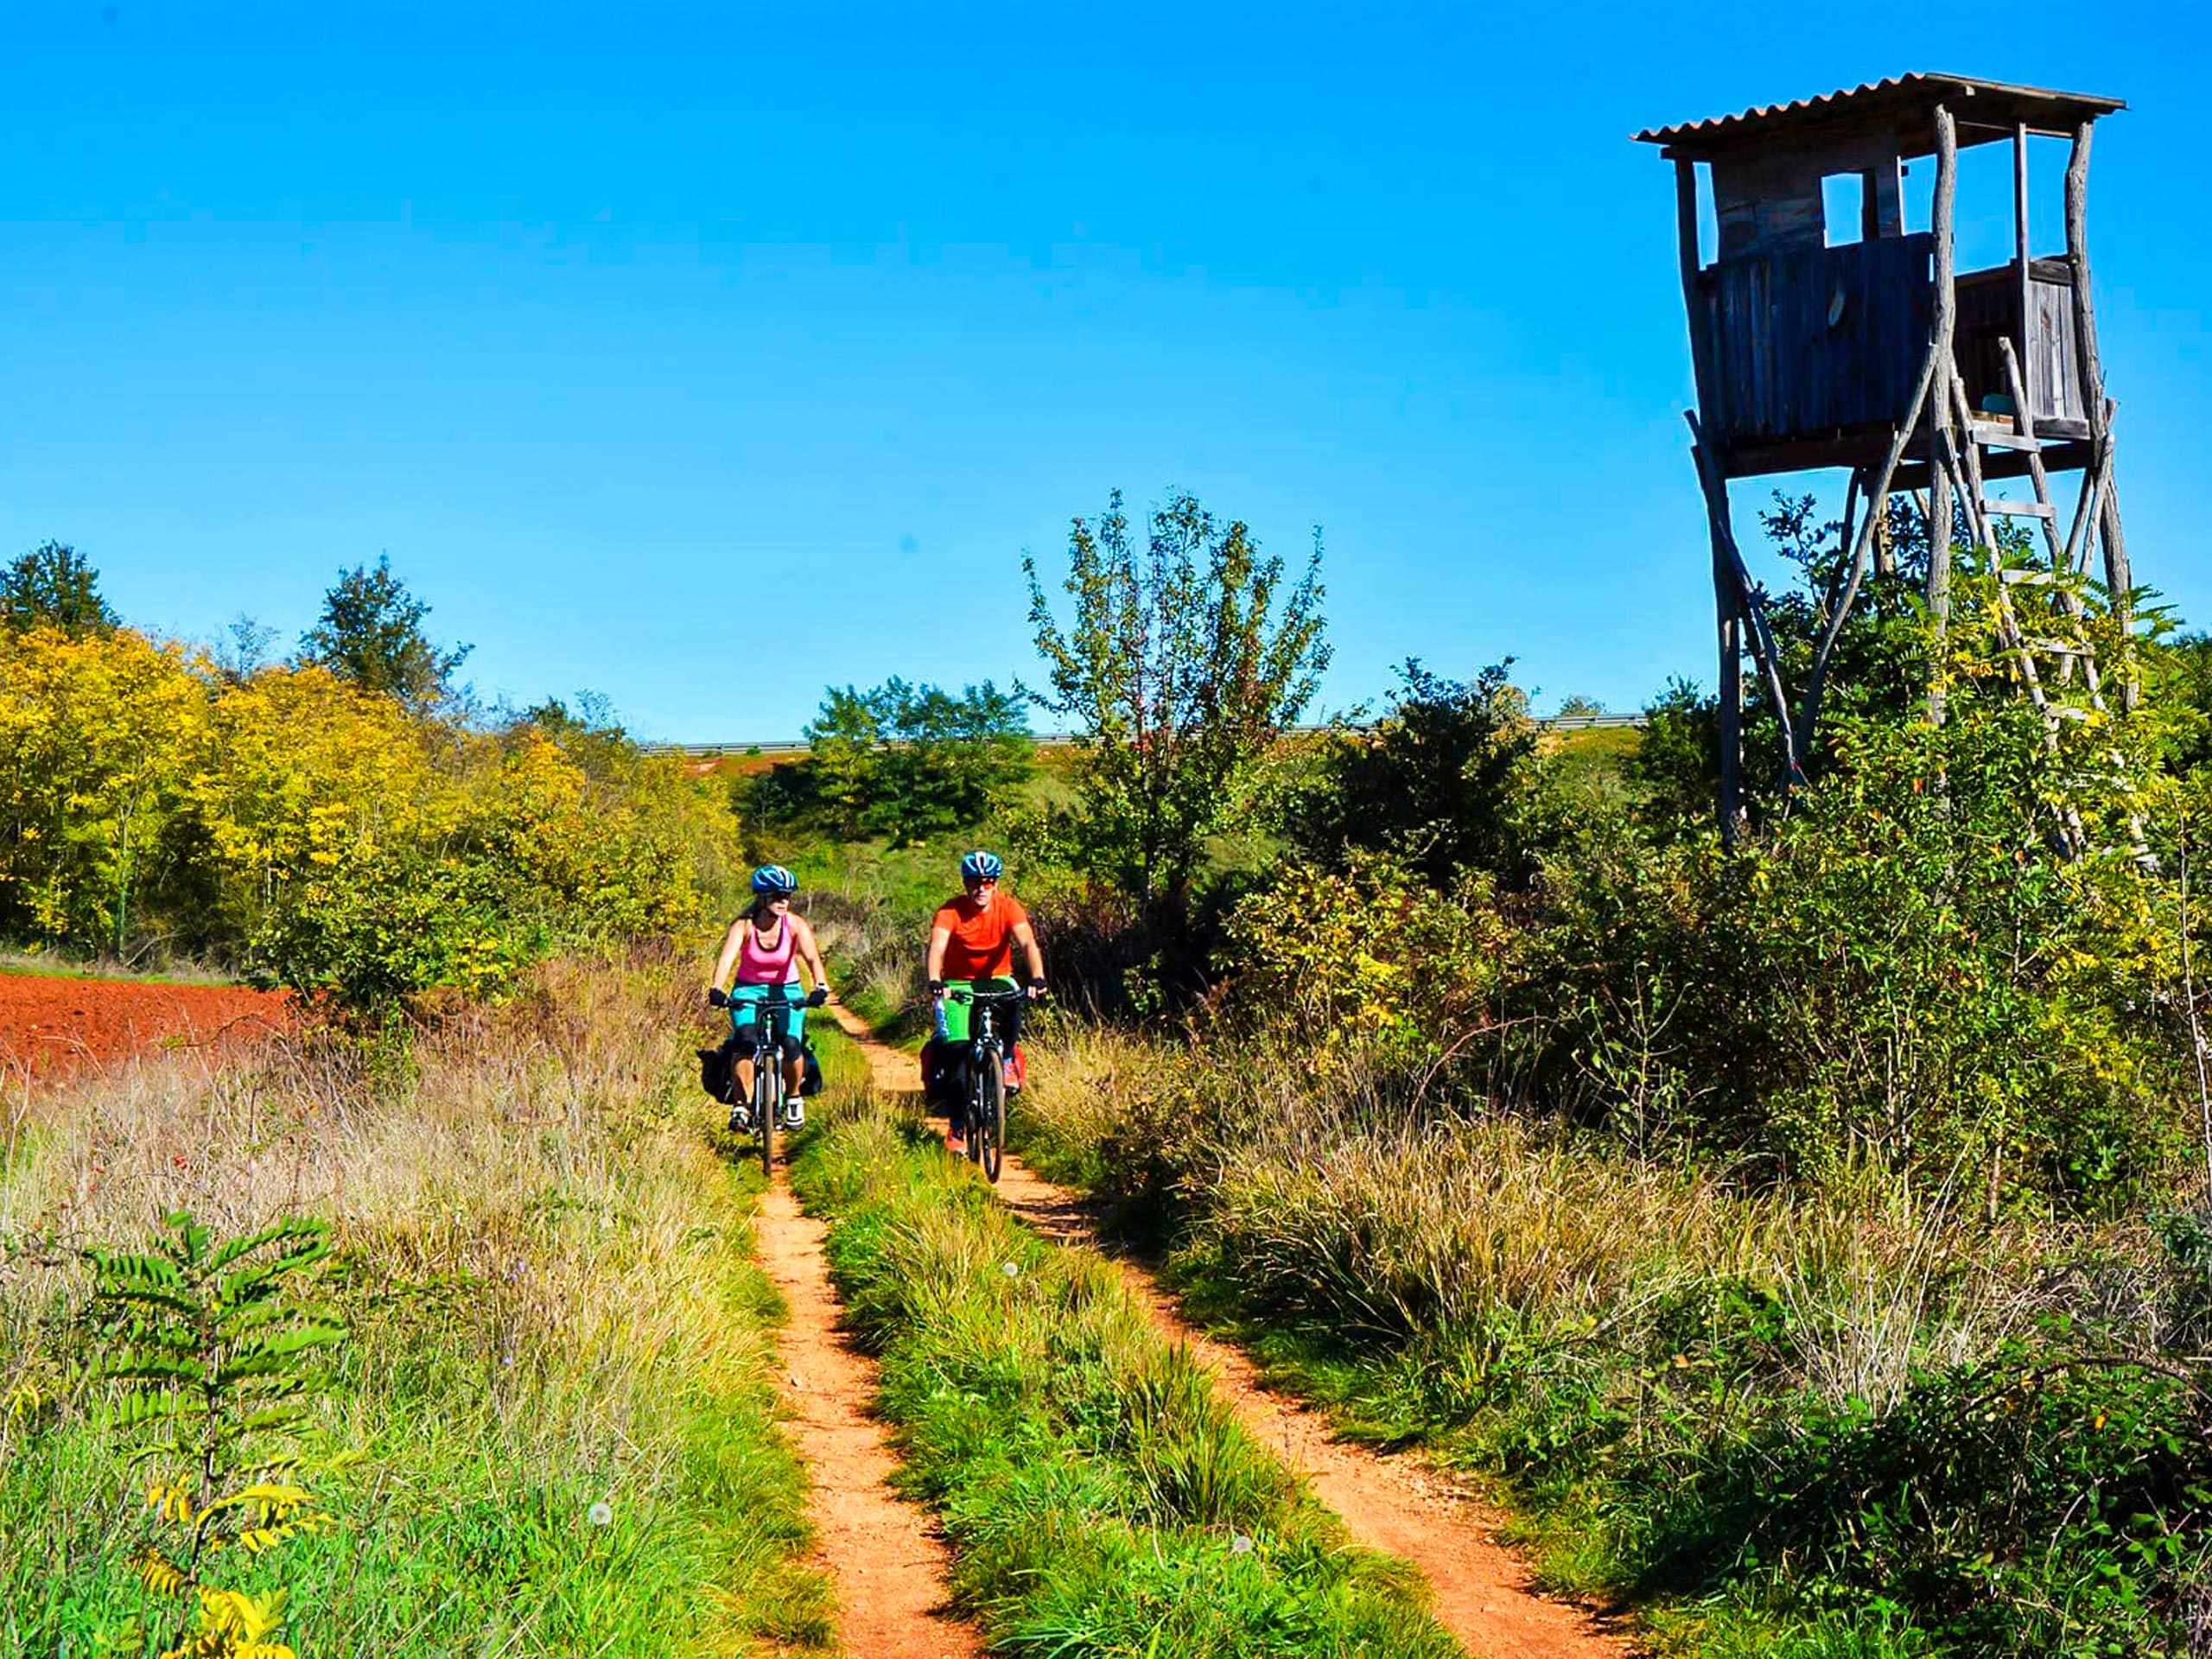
0, 0, 2212, 741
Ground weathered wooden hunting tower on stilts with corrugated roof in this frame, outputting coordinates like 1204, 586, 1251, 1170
1637, 75, 2128, 836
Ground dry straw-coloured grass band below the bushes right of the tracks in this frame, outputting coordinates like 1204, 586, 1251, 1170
1024, 1027, 2152, 1409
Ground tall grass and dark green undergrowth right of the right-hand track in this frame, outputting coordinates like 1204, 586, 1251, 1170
1020, 1028, 2212, 1655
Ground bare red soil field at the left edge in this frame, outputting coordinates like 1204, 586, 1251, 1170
0, 973, 292, 1079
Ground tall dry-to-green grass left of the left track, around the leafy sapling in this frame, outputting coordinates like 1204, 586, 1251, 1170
0, 960, 832, 1655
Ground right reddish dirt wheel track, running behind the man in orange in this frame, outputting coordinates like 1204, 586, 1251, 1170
832, 1007, 1632, 1659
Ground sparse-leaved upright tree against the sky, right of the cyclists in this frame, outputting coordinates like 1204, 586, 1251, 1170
1022, 491, 1330, 905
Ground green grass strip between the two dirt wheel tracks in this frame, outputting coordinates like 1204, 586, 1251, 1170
791, 1035, 1460, 1659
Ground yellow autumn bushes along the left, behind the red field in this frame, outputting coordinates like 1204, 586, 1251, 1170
0, 631, 736, 1002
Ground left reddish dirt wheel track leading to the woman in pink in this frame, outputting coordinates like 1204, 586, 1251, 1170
759, 1179, 982, 1659
